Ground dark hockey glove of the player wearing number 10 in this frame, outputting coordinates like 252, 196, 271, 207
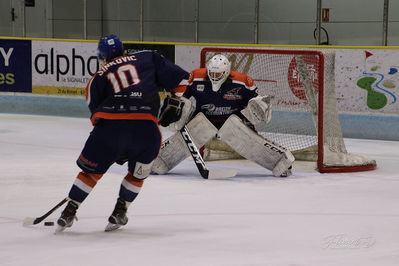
159, 96, 184, 127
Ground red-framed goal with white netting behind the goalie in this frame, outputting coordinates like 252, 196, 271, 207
201, 48, 376, 173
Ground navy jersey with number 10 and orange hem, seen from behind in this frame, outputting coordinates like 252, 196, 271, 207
86, 51, 189, 125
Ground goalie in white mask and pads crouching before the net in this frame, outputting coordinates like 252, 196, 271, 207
152, 55, 294, 176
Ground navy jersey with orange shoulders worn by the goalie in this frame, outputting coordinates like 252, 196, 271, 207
184, 68, 258, 128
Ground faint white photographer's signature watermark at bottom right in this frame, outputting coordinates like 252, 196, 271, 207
323, 234, 376, 249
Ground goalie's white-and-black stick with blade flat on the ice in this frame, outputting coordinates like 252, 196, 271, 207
180, 126, 237, 179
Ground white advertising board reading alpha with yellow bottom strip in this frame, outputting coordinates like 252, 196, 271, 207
32, 41, 99, 96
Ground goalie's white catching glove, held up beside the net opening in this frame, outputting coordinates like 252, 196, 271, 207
241, 95, 273, 125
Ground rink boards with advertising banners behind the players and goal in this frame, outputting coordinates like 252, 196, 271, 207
0, 37, 399, 140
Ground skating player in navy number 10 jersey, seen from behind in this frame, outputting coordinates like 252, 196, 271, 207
56, 35, 189, 232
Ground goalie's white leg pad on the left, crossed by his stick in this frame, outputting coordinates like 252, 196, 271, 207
152, 113, 217, 174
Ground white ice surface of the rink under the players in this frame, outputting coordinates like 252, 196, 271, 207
0, 114, 399, 266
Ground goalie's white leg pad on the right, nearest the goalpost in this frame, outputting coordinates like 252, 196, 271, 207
218, 115, 295, 176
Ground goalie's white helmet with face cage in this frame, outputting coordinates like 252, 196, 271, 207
206, 54, 231, 91
